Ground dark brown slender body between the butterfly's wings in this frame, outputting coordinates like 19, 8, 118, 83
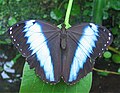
60, 27, 67, 50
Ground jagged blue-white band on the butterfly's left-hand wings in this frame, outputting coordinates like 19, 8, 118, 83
23, 20, 54, 81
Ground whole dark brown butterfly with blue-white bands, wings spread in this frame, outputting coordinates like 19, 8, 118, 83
8, 20, 113, 84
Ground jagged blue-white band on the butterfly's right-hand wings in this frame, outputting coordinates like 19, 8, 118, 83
69, 23, 98, 82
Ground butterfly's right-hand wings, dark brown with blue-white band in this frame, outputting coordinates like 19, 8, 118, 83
62, 23, 112, 84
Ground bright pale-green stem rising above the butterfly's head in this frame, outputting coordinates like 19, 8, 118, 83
64, 0, 73, 29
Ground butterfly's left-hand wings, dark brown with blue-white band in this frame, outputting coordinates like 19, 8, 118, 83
8, 20, 61, 83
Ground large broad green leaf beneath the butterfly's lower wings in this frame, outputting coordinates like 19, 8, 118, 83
20, 62, 92, 93
